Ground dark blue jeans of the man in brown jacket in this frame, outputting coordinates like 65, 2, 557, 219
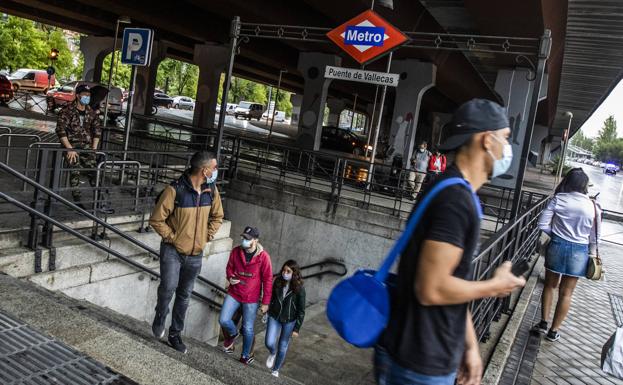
154, 242, 203, 335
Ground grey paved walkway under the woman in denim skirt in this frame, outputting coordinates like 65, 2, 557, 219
500, 218, 623, 385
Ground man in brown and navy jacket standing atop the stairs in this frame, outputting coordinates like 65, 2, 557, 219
149, 152, 223, 353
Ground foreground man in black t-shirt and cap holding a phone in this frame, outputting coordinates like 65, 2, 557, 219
375, 99, 525, 385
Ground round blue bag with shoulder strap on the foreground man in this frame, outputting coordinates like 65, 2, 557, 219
327, 178, 482, 348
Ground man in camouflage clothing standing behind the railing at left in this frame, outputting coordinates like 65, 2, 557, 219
56, 84, 102, 204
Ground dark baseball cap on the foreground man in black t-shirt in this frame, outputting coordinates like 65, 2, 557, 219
439, 99, 509, 151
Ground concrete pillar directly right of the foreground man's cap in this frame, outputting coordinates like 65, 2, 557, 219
491, 68, 547, 188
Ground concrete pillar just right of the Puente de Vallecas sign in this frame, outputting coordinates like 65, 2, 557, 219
389, 59, 437, 166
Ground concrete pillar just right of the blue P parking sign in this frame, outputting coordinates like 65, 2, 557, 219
133, 41, 167, 115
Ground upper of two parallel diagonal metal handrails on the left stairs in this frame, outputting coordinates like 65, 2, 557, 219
0, 162, 228, 290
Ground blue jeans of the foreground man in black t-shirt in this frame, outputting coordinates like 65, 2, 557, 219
374, 346, 456, 385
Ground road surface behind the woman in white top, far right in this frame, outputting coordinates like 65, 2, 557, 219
570, 162, 623, 212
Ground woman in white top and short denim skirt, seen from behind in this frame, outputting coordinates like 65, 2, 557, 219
532, 168, 602, 342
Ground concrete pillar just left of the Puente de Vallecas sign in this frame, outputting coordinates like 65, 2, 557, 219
297, 52, 342, 151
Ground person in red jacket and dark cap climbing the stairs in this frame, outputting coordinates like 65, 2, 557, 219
219, 226, 273, 365
